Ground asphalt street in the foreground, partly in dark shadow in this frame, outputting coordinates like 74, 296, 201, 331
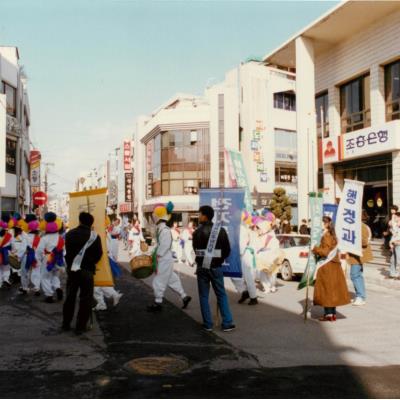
0, 245, 400, 398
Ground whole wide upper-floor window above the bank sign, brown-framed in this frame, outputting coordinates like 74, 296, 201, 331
340, 74, 371, 133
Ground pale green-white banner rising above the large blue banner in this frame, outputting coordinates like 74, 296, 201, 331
225, 150, 253, 213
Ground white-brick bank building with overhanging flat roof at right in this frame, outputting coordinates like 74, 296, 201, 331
265, 1, 400, 234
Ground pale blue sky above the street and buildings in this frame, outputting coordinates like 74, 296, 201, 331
0, 0, 337, 194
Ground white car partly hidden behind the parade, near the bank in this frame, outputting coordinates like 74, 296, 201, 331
276, 233, 310, 281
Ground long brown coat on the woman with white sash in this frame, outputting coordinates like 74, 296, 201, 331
313, 232, 350, 307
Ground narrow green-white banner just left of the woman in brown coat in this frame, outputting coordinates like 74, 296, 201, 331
297, 192, 322, 289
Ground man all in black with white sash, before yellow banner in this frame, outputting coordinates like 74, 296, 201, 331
62, 212, 103, 335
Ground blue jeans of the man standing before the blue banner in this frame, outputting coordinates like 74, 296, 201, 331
197, 266, 233, 328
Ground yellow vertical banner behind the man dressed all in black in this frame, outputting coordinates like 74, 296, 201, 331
69, 188, 114, 286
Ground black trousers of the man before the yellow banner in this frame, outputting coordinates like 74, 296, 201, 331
63, 270, 94, 331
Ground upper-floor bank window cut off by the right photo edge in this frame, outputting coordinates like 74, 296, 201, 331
385, 60, 400, 121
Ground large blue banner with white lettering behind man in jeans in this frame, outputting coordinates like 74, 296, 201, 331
200, 188, 245, 278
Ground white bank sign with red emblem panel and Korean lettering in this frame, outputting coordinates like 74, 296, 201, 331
322, 121, 400, 164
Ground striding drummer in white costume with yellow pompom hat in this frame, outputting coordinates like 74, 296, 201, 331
147, 202, 192, 312
